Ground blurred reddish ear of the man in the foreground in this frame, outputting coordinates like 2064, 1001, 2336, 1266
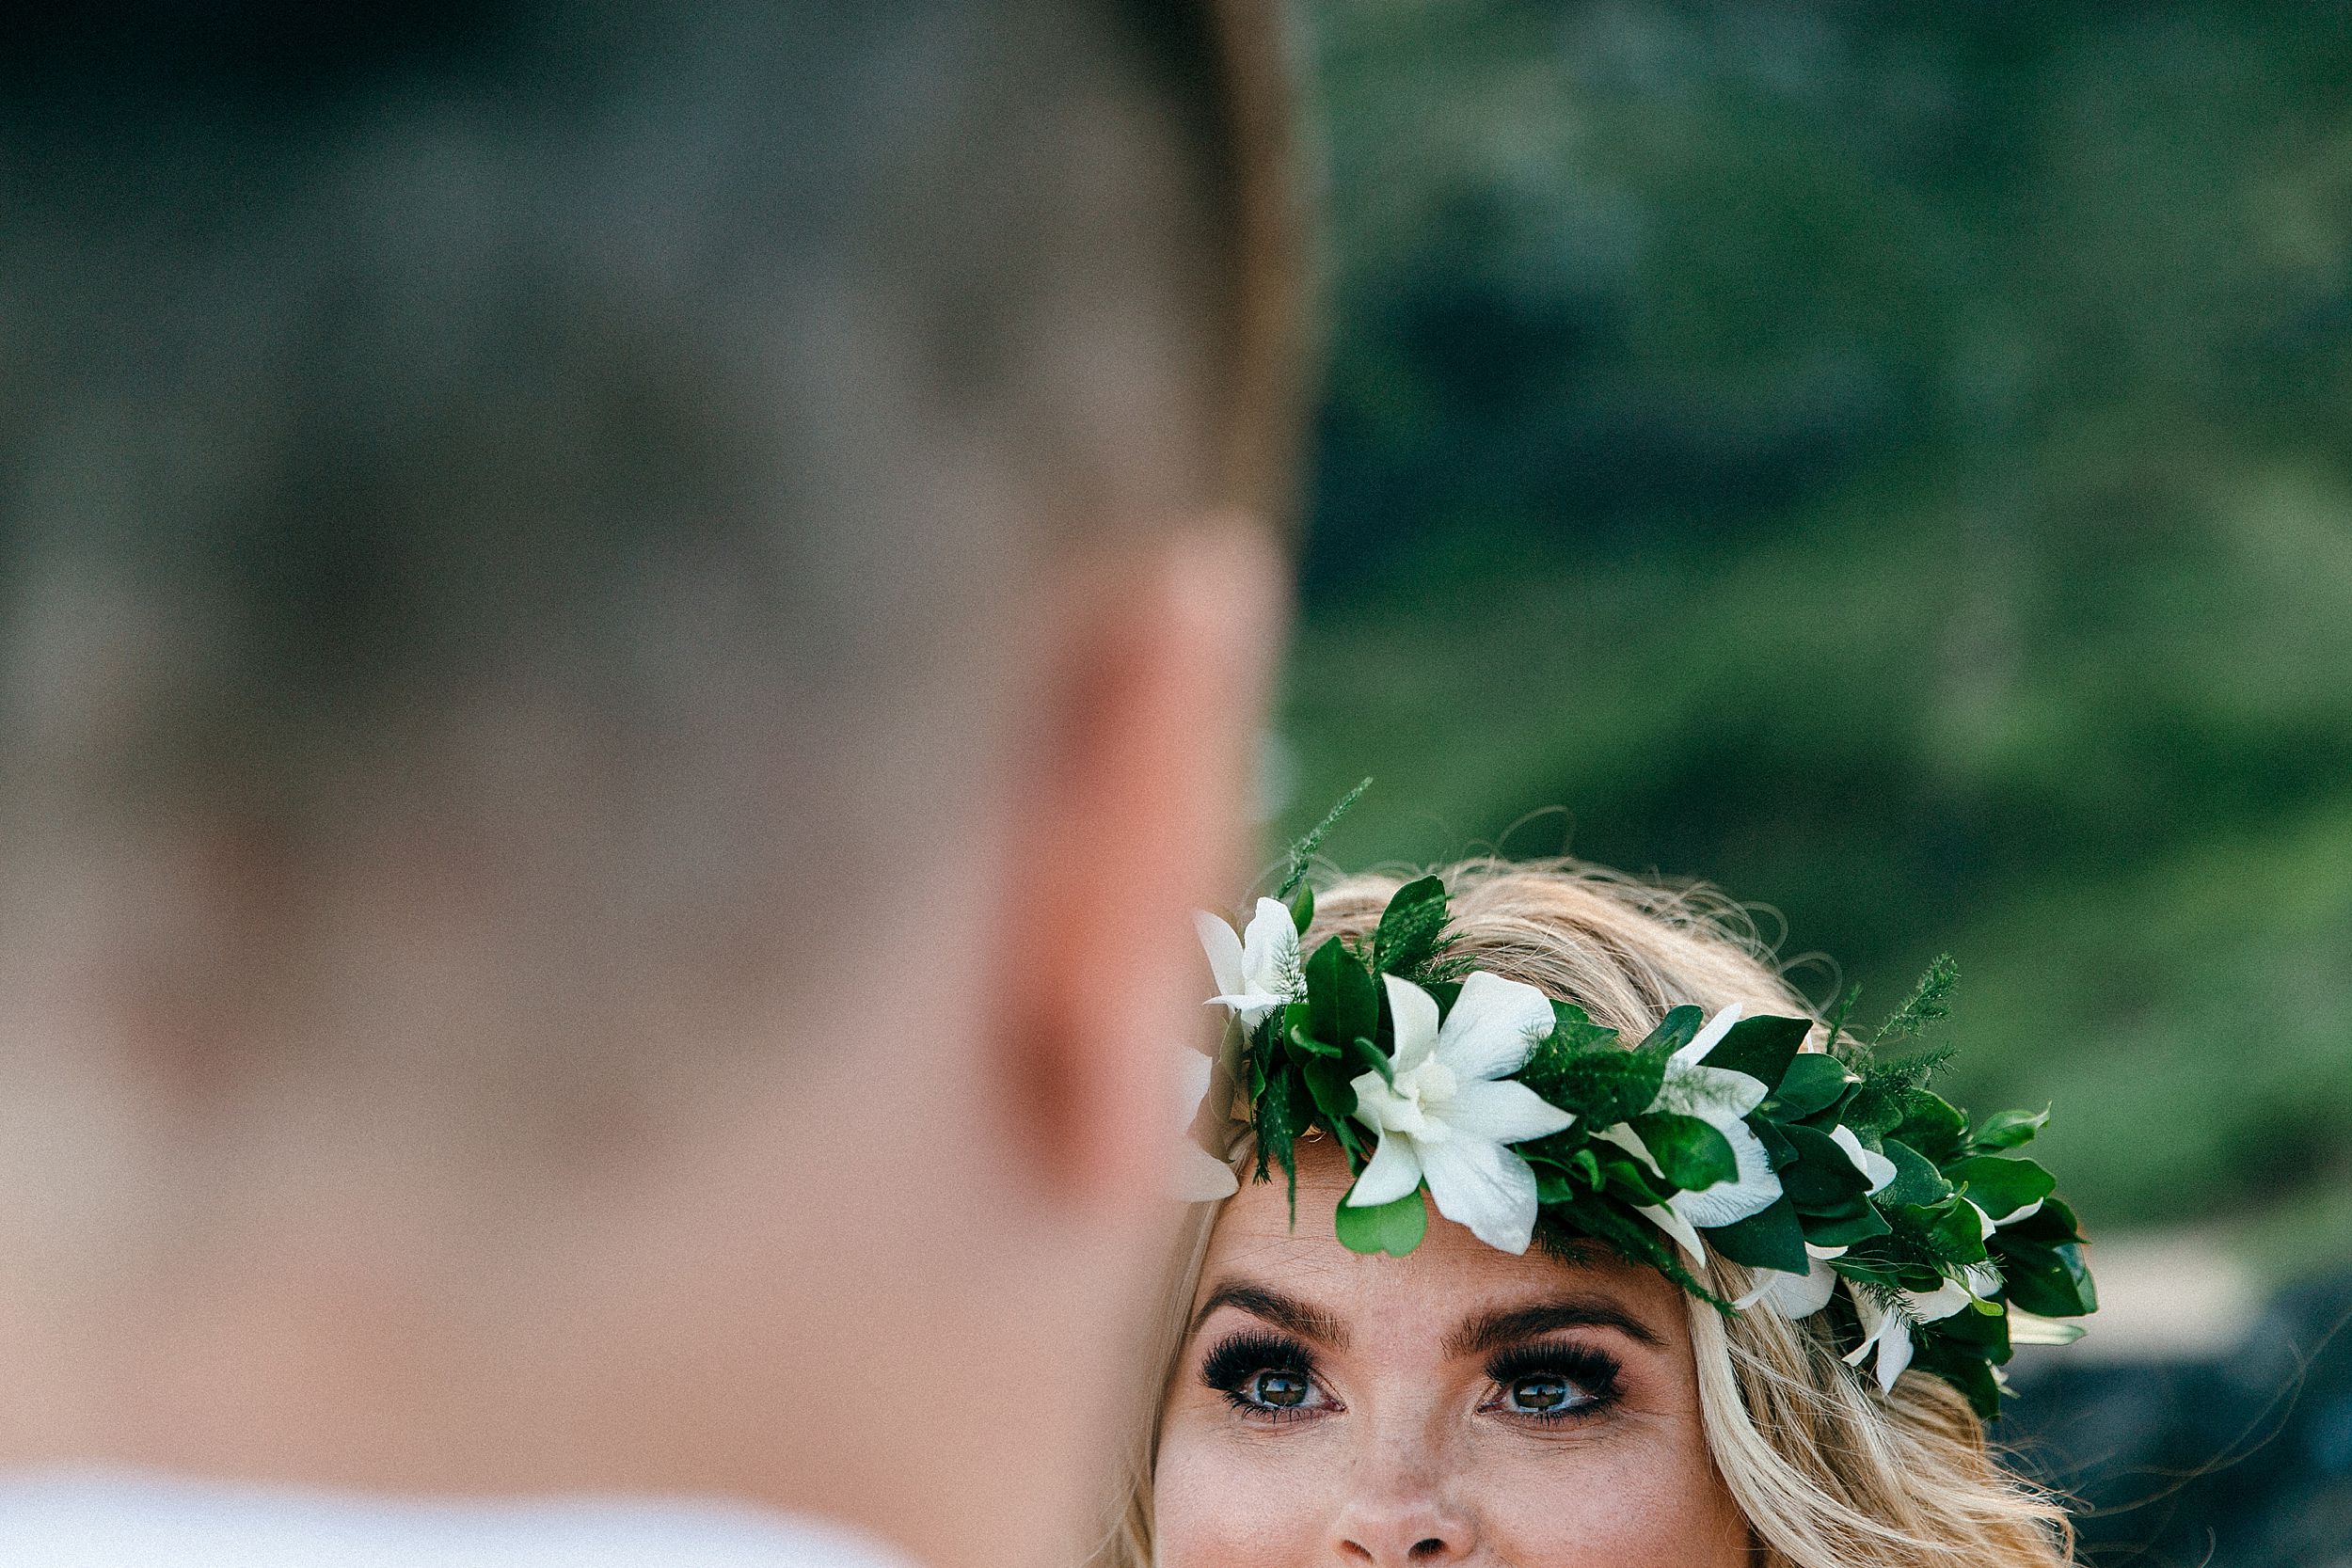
993, 527, 1289, 1206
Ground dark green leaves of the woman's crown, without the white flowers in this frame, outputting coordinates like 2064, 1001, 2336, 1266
1245, 860, 2096, 1402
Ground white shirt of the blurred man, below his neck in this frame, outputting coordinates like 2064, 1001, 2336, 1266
0, 1474, 906, 1568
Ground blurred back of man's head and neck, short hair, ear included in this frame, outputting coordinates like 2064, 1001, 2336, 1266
0, 0, 1292, 1561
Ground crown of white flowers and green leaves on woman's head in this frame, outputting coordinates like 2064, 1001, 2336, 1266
1185, 856, 2098, 1420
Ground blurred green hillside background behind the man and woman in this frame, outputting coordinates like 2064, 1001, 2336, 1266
1275, 0, 2352, 1279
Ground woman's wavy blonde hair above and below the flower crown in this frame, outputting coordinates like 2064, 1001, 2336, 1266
1094, 861, 2074, 1568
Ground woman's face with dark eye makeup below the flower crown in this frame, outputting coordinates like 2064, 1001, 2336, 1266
1155, 1143, 1750, 1568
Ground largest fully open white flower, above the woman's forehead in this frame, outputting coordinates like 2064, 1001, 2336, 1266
1348, 974, 1576, 1253
